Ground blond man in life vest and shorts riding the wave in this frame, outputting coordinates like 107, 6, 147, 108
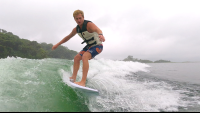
52, 10, 105, 87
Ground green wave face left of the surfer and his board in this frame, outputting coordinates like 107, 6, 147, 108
0, 58, 89, 112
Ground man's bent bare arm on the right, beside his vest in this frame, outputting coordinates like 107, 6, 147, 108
87, 22, 105, 42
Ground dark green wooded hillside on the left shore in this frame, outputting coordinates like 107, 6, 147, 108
0, 29, 77, 60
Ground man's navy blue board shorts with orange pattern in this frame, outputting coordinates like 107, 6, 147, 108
79, 44, 103, 59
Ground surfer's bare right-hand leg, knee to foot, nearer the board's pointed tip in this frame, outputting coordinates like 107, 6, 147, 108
75, 52, 92, 86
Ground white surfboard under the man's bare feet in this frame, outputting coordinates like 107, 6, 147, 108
69, 81, 99, 93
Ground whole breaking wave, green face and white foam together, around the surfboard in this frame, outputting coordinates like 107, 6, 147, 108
0, 57, 200, 112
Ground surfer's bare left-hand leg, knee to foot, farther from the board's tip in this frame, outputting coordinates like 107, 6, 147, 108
70, 54, 82, 82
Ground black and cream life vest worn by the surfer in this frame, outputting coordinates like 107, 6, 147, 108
76, 20, 102, 47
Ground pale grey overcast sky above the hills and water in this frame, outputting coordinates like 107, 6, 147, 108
0, 0, 200, 62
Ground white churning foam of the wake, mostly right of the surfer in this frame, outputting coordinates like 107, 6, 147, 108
60, 59, 189, 112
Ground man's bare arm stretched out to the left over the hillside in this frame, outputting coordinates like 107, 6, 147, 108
52, 27, 77, 50
